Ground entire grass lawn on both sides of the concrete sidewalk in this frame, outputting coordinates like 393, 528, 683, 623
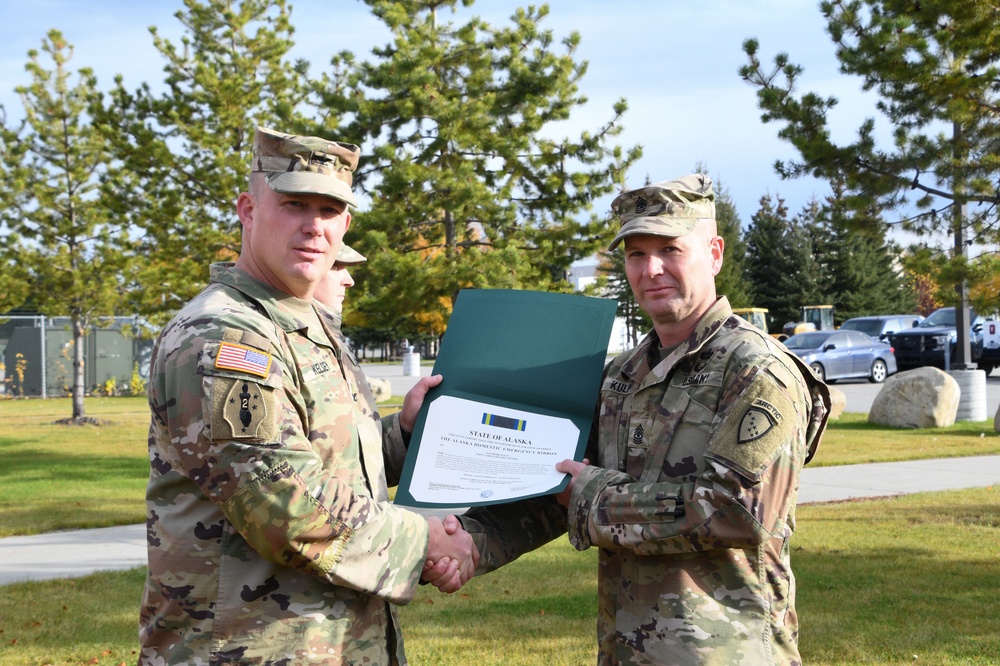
0, 398, 1000, 666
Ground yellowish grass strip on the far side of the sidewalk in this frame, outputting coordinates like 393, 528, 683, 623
0, 396, 1000, 537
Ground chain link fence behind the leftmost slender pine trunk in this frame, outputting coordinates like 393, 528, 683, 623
0, 315, 155, 398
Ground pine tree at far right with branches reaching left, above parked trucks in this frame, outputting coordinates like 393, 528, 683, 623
740, 0, 1000, 368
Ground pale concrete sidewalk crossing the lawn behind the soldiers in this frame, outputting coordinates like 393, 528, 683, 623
0, 456, 1000, 585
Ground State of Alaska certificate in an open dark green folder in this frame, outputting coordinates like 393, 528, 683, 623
395, 289, 617, 509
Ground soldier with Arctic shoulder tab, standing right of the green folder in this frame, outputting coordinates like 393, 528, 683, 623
428, 174, 830, 666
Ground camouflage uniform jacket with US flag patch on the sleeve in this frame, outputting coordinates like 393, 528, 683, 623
139, 265, 428, 665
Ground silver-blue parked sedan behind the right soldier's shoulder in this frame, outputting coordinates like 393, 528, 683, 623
785, 329, 896, 384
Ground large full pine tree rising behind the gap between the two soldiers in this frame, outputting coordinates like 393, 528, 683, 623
324, 0, 640, 334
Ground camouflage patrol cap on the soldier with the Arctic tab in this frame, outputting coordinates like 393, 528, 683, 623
608, 173, 715, 250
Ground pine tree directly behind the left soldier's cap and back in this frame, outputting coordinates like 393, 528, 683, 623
105, 0, 315, 320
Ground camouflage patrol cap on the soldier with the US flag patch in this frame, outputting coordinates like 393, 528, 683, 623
250, 127, 361, 206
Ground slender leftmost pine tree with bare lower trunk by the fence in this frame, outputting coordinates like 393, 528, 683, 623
0, 30, 136, 422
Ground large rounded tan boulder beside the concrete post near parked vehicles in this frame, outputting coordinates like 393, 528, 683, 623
868, 367, 961, 428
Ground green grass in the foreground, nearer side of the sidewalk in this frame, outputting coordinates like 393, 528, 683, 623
0, 488, 1000, 666
